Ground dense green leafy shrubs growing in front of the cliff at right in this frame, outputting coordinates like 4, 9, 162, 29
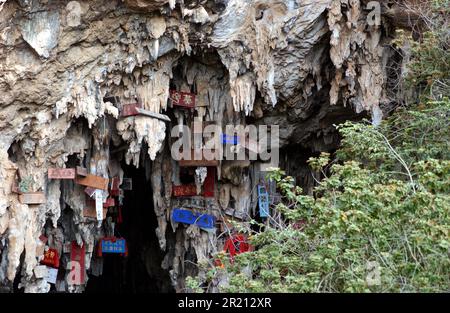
188, 0, 450, 292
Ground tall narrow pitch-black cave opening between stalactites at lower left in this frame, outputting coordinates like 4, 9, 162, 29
86, 149, 174, 293
